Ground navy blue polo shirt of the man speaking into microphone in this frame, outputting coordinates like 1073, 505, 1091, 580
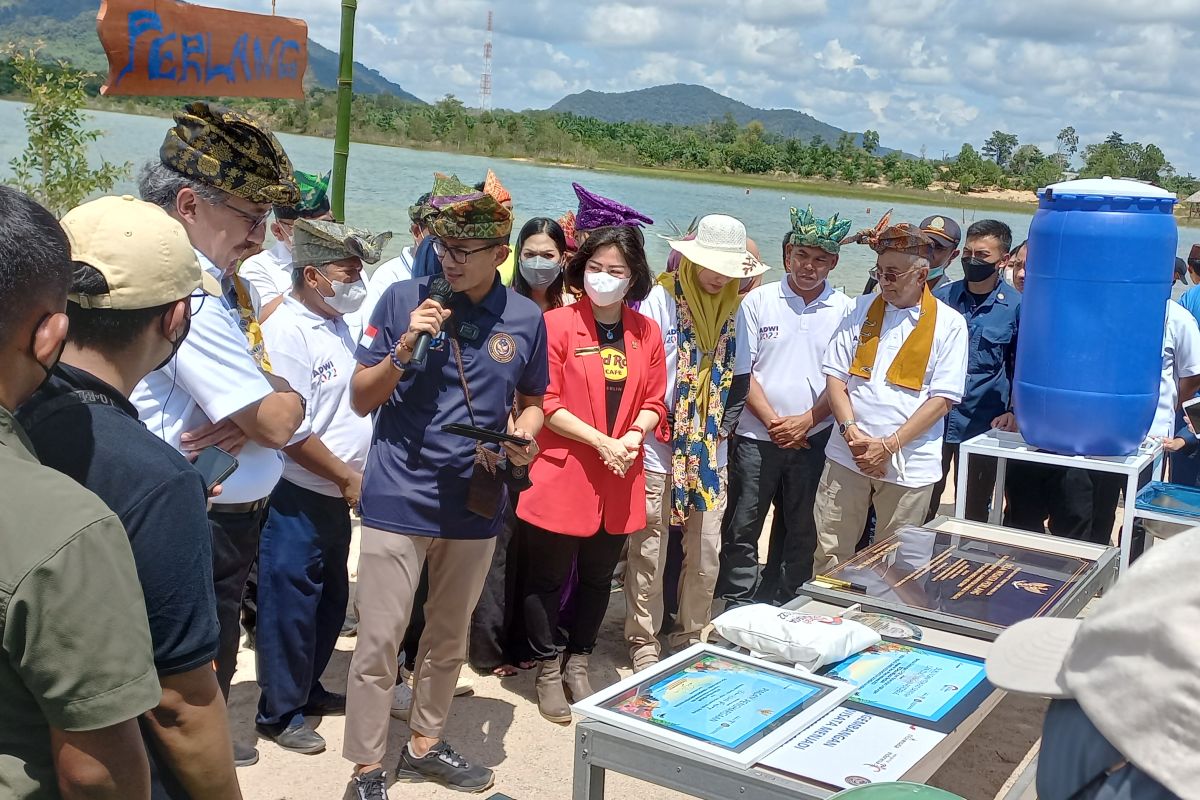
355, 276, 550, 539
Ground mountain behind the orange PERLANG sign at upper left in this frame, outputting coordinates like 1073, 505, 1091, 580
0, 0, 425, 104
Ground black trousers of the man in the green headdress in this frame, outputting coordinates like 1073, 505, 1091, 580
716, 428, 833, 604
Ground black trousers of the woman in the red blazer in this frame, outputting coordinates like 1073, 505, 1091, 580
522, 525, 626, 661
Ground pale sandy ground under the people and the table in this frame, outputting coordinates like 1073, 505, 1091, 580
230, 489, 1044, 800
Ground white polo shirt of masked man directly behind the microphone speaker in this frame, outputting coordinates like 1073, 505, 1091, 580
263, 294, 372, 498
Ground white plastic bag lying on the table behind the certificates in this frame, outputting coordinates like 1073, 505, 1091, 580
713, 603, 882, 669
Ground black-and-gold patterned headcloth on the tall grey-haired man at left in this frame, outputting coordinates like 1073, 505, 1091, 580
158, 102, 300, 205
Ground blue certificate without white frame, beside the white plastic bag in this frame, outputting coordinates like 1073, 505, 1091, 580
821, 639, 995, 733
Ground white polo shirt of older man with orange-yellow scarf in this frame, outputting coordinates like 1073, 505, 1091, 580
824, 294, 968, 488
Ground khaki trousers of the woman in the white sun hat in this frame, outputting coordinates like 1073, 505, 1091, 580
625, 469, 727, 651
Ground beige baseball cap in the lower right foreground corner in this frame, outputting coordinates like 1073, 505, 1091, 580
988, 528, 1200, 799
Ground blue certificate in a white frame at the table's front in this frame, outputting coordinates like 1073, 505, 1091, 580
571, 644, 854, 768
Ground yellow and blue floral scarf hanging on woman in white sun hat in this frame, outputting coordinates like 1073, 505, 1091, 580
666, 264, 738, 525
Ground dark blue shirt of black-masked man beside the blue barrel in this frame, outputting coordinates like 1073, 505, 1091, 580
934, 278, 1021, 445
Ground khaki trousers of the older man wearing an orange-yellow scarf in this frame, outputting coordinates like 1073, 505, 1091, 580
814, 458, 934, 575
